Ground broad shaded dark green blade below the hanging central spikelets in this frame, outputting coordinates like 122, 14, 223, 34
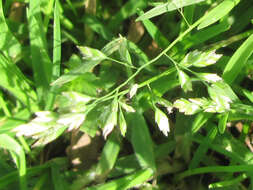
127, 112, 156, 171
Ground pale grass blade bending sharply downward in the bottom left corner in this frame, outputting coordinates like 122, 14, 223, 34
0, 134, 27, 190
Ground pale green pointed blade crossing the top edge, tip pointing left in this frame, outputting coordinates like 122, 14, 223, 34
136, 0, 205, 21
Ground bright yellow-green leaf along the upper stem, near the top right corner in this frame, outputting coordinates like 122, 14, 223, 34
198, 0, 240, 30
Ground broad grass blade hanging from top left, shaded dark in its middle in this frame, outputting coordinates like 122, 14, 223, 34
28, 0, 52, 102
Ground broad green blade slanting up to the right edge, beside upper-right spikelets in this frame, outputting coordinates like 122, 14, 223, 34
222, 34, 253, 84
